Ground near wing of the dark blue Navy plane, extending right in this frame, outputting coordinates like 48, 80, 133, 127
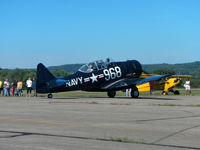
101, 75, 170, 90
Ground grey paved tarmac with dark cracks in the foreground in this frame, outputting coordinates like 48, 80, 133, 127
0, 96, 200, 150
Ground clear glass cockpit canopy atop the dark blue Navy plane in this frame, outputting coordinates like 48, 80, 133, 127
79, 58, 113, 73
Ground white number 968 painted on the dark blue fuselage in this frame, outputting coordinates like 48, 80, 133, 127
103, 66, 122, 81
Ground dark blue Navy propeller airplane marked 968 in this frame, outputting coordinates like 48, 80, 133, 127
36, 60, 169, 98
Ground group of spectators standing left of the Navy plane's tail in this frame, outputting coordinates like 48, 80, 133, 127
0, 77, 37, 97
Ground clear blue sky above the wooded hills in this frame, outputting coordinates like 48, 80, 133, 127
0, 0, 200, 68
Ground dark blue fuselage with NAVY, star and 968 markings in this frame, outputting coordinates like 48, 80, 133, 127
37, 60, 142, 93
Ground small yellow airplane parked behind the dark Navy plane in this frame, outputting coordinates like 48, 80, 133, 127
137, 74, 191, 95
